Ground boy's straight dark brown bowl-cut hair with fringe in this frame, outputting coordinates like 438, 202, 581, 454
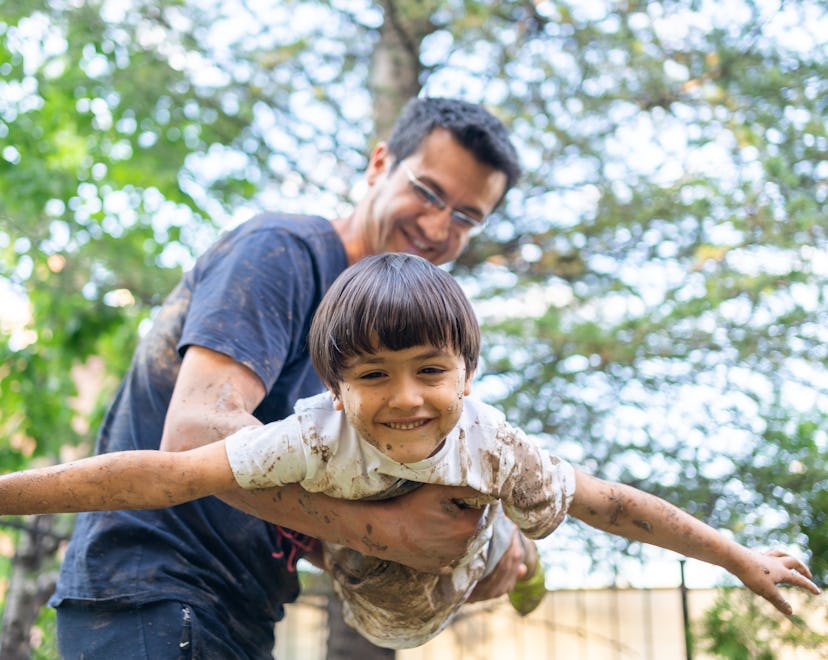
308, 253, 480, 394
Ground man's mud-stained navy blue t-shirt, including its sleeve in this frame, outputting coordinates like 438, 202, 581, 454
49, 214, 347, 637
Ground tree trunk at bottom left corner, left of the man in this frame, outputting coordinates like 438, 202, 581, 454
0, 515, 62, 660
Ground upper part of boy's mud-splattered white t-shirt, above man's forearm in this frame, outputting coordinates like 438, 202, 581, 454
226, 393, 575, 538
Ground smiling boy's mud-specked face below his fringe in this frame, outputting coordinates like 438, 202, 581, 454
334, 345, 473, 463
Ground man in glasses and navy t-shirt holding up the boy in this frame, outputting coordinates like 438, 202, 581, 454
50, 99, 525, 660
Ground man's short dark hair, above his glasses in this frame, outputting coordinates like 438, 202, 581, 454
388, 97, 520, 196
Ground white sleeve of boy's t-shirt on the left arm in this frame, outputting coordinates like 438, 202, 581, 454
224, 415, 308, 490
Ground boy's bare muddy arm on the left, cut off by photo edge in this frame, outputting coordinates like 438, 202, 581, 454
0, 442, 236, 515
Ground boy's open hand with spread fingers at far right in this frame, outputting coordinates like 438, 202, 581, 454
734, 550, 820, 614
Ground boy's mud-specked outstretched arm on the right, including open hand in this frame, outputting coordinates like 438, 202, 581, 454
569, 471, 820, 614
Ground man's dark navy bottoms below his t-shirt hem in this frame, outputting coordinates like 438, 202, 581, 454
57, 600, 274, 660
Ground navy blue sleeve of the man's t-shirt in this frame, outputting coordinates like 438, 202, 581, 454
178, 231, 318, 390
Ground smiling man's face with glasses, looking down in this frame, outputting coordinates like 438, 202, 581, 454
361, 129, 506, 264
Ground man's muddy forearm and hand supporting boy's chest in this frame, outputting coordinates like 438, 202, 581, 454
221, 485, 481, 572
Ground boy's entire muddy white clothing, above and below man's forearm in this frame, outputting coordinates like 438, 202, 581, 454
226, 393, 575, 648
